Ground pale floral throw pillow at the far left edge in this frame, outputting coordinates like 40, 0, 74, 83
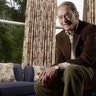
0, 63, 15, 82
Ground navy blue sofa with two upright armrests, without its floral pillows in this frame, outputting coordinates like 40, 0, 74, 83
0, 64, 36, 96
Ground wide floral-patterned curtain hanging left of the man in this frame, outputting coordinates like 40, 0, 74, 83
22, 0, 57, 68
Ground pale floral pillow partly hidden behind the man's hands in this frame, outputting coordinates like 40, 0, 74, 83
33, 65, 45, 81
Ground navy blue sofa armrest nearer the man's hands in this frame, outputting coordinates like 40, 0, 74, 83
24, 66, 34, 82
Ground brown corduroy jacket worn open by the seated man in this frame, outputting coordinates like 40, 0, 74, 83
56, 21, 96, 68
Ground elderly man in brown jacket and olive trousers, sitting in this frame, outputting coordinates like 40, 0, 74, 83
35, 2, 96, 96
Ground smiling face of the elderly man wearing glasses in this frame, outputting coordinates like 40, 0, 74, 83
57, 5, 79, 31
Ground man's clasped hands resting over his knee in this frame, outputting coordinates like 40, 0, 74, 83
39, 67, 57, 85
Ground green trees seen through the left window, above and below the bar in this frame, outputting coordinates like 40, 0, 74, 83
0, 0, 27, 63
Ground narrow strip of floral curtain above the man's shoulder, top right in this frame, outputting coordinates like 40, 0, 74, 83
84, 0, 96, 24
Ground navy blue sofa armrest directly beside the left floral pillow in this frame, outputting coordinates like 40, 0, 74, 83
13, 64, 24, 81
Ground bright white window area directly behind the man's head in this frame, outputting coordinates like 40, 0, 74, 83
56, 0, 83, 34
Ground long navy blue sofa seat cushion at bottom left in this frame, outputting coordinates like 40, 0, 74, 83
0, 81, 35, 96
